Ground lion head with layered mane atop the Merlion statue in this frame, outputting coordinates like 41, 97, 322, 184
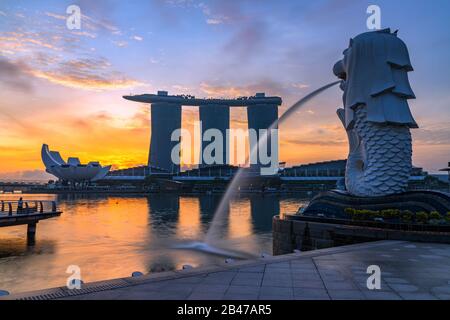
333, 29, 418, 129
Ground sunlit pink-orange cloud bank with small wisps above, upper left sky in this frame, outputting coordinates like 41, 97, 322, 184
0, 12, 143, 90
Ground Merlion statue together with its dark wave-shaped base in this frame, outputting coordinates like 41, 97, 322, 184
300, 29, 450, 221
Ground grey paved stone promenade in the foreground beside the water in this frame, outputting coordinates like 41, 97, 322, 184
6, 241, 450, 300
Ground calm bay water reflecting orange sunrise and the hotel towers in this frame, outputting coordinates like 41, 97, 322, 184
0, 194, 304, 292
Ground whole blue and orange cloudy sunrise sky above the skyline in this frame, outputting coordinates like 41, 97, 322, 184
0, 0, 450, 179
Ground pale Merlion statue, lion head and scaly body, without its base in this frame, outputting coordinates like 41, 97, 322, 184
333, 29, 418, 197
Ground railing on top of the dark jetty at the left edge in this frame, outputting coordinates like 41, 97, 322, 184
0, 200, 58, 216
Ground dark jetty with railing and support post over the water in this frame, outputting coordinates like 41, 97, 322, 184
0, 200, 61, 245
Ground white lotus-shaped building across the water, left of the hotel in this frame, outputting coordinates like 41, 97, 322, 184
41, 144, 111, 182
